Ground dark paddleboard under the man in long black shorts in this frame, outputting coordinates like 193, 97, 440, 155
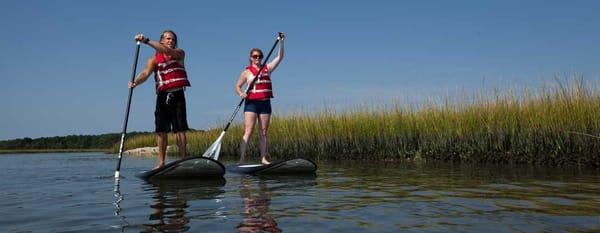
137, 156, 225, 180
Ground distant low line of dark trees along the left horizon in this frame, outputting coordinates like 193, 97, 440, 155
0, 132, 147, 150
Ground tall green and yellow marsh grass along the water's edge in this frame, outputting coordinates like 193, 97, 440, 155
116, 79, 600, 167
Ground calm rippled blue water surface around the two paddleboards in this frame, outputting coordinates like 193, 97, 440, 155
0, 153, 600, 233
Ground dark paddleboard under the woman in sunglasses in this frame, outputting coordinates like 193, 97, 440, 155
227, 158, 317, 175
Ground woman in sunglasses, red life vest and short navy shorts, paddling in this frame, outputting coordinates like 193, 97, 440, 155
235, 33, 285, 164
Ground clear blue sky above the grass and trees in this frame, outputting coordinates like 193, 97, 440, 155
0, 0, 600, 140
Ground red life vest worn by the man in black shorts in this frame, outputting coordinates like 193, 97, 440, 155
154, 53, 190, 92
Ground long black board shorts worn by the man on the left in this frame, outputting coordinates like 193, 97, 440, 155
154, 90, 189, 133
